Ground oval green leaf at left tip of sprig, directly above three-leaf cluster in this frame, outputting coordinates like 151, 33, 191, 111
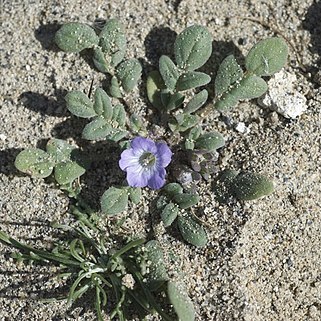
65, 90, 96, 118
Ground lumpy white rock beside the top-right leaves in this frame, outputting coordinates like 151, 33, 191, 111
258, 70, 308, 119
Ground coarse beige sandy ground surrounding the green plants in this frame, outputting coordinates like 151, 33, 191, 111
0, 0, 321, 321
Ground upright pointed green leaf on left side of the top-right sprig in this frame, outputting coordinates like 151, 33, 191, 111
215, 55, 243, 96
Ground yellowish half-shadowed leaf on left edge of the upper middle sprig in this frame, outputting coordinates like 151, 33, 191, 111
146, 70, 165, 110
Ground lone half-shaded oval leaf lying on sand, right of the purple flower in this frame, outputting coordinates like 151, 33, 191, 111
231, 172, 274, 201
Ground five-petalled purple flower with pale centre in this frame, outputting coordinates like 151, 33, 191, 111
119, 136, 173, 189
